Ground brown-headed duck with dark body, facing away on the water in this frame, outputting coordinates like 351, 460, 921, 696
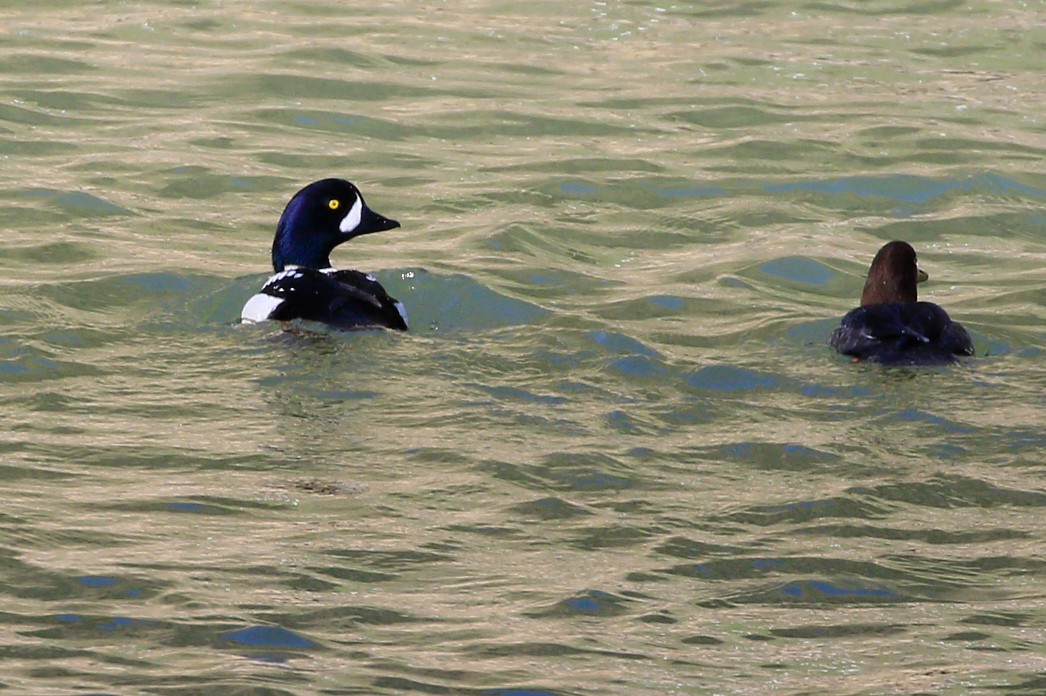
828, 241, 974, 365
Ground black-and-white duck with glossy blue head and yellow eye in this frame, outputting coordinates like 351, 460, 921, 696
241, 179, 407, 331
